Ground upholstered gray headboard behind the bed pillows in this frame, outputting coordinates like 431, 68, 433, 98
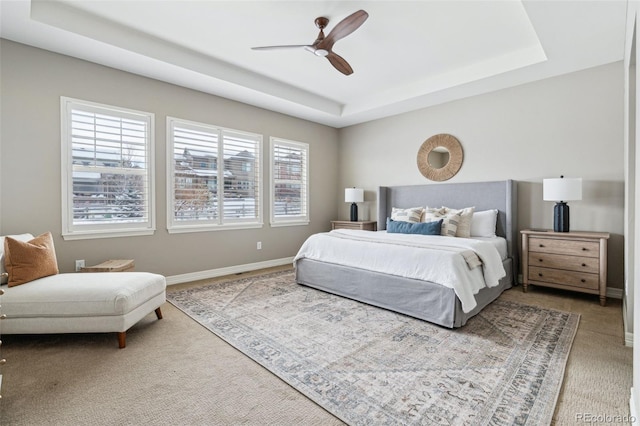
378, 180, 518, 271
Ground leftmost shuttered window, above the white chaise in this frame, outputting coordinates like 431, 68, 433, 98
60, 97, 155, 239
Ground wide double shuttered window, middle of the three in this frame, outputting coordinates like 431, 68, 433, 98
167, 117, 262, 232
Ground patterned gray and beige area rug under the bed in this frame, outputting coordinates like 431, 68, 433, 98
167, 271, 579, 425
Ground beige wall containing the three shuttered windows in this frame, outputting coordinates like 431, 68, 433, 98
0, 40, 339, 276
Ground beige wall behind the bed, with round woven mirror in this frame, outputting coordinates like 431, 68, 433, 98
338, 62, 624, 289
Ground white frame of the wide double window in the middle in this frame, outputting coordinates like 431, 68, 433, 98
166, 116, 264, 234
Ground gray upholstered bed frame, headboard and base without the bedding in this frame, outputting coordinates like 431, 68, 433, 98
294, 180, 518, 328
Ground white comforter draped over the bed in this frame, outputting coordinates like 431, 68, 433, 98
294, 229, 506, 312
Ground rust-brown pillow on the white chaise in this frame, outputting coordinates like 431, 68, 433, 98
4, 232, 58, 287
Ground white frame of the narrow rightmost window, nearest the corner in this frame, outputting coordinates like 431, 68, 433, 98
269, 136, 311, 227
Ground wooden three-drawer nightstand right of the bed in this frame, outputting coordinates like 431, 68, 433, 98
521, 229, 609, 306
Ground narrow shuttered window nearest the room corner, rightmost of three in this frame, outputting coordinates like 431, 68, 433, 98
270, 138, 309, 226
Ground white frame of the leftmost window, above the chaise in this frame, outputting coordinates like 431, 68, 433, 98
60, 96, 156, 240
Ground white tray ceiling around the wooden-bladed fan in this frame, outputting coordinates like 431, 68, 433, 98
0, 0, 627, 127
